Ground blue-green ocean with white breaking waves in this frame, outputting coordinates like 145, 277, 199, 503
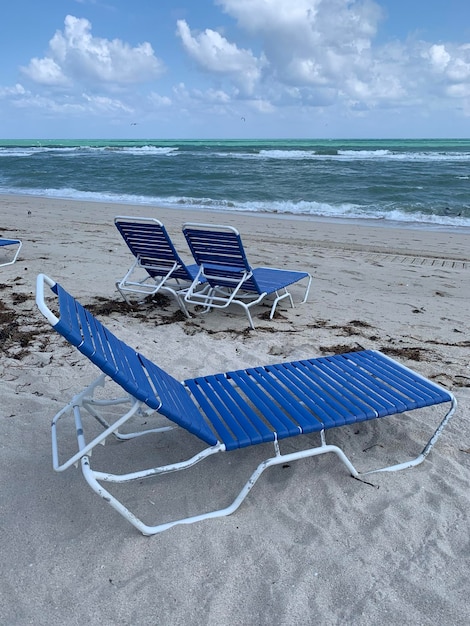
0, 139, 470, 228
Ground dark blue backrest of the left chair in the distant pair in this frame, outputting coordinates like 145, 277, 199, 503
114, 216, 192, 280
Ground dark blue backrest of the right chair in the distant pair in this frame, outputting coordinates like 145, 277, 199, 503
183, 222, 258, 291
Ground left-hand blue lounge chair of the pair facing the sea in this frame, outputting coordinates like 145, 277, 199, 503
114, 216, 204, 317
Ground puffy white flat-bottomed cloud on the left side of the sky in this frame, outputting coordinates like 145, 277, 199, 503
22, 15, 164, 88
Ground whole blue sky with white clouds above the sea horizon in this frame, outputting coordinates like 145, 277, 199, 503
0, 0, 470, 139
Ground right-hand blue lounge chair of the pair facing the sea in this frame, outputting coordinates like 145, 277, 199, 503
183, 223, 312, 328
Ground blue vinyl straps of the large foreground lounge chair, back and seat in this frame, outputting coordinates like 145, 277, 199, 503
48, 283, 452, 450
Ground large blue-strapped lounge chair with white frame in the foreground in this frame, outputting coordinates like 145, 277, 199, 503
36, 274, 456, 535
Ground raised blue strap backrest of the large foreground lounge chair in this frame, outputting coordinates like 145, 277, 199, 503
44, 275, 217, 445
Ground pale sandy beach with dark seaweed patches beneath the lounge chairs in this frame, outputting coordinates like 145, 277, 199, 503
0, 196, 470, 626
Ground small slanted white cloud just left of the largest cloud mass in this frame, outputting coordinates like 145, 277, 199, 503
177, 20, 263, 93
